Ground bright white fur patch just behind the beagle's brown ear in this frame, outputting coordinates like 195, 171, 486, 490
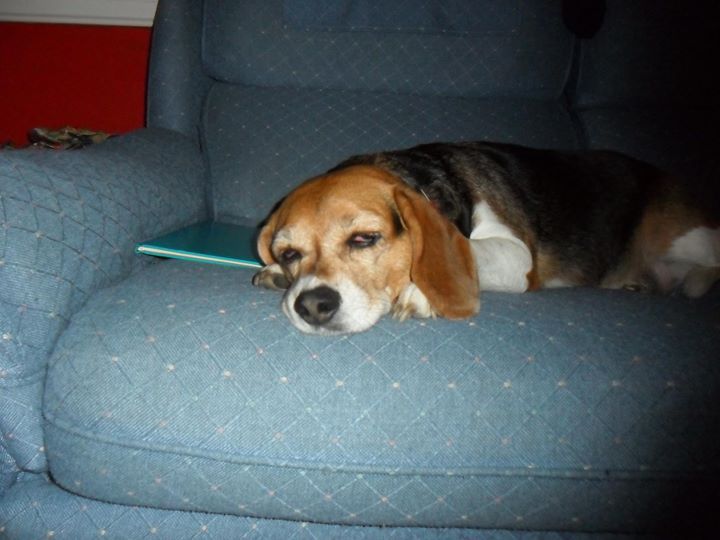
470, 201, 533, 292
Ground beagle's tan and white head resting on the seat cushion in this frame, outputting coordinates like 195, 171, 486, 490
258, 166, 479, 334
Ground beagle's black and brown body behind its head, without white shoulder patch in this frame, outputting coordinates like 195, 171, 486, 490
334, 142, 720, 296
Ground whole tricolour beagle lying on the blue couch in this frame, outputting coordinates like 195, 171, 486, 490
253, 142, 720, 334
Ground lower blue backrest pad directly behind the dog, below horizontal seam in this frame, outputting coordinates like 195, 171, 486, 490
203, 84, 577, 221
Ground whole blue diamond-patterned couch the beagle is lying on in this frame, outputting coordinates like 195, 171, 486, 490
0, 0, 720, 540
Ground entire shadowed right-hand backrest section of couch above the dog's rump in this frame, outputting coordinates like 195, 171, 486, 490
573, 0, 720, 181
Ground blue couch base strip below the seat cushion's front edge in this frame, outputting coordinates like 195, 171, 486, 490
0, 475, 640, 540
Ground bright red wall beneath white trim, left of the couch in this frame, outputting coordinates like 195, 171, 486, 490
0, 23, 150, 145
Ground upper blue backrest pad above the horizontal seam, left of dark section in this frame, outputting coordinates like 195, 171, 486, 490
203, 0, 573, 99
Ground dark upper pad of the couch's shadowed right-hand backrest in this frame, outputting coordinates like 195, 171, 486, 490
577, 0, 720, 108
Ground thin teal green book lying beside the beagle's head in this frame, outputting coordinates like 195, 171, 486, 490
135, 221, 263, 268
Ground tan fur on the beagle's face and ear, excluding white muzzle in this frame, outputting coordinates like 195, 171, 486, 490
256, 166, 479, 324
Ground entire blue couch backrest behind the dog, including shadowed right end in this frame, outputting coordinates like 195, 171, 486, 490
148, 0, 720, 221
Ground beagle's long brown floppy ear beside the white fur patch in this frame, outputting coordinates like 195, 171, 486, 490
395, 188, 480, 319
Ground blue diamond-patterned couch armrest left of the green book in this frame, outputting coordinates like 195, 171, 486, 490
0, 130, 205, 470
